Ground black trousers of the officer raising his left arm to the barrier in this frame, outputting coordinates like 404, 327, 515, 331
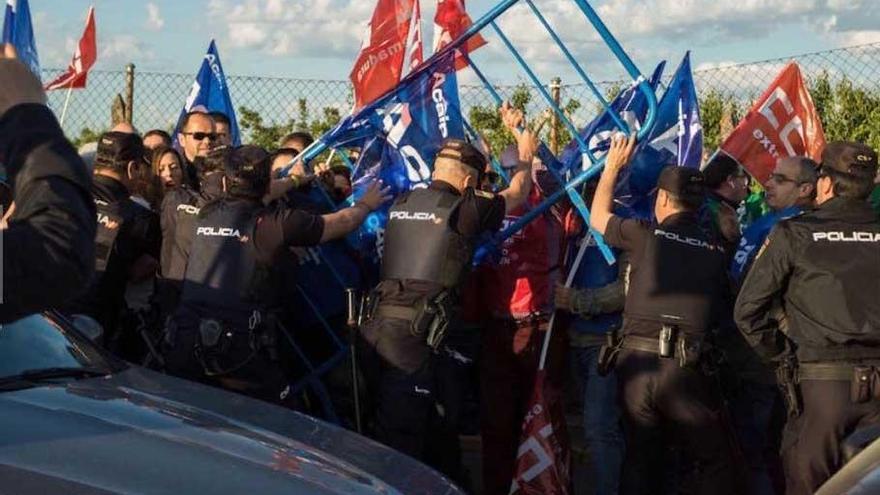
615, 349, 745, 495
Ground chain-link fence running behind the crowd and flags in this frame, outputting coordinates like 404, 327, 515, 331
43, 43, 880, 149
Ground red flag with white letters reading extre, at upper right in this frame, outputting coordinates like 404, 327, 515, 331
721, 62, 825, 184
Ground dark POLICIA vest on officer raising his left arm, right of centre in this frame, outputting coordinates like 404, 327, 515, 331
624, 214, 727, 336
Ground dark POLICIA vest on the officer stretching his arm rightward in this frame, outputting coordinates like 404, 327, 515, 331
180, 200, 267, 329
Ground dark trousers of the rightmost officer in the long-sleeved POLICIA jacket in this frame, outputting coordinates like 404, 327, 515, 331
782, 380, 880, 495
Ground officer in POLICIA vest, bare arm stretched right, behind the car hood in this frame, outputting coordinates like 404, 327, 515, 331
166, 146, 386, 404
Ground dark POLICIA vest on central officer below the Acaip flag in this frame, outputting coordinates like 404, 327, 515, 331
381, 189, 473, 288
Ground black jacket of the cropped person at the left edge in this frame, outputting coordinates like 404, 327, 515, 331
0, 104, 96, 323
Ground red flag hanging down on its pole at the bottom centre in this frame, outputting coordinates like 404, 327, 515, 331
510, 370, 571, 495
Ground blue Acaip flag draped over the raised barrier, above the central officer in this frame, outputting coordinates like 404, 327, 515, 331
323, 52, 465, 256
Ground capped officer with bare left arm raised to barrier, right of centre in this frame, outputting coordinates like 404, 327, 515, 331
590, 136, 736, 494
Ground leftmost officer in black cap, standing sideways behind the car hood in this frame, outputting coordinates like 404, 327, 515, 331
69, 132, 161, 352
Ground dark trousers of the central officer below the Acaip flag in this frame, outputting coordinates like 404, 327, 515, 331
358, 318, 463, 483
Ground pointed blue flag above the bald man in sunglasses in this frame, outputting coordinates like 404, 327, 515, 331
174, 40, 241, 146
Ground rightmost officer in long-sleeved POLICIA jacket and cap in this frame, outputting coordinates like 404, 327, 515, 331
735, 142, 880, 494
